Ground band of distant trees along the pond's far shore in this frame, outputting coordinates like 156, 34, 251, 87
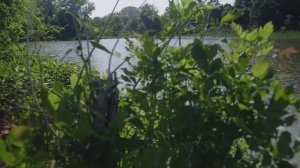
31, 0, 300, 40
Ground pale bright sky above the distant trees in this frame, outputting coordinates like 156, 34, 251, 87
90, 0, 234, 17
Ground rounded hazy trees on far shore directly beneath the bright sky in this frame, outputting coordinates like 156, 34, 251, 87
93, 4, 162, 37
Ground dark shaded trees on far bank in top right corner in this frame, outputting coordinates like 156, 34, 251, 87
234, 0, 300, 30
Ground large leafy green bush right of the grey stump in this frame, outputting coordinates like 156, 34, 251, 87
117, 18, 296, 167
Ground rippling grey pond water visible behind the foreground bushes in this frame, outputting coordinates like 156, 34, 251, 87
32, 37, 300, 90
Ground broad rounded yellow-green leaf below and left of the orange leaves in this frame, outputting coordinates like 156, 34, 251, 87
253, 59, 270, 79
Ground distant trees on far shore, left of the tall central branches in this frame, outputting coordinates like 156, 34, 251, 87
35, 0, 161, 40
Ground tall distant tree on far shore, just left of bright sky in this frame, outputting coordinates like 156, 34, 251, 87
37, 0, 95, 39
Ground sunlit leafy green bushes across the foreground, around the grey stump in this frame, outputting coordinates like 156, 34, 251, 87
0, 0, 299, 168
